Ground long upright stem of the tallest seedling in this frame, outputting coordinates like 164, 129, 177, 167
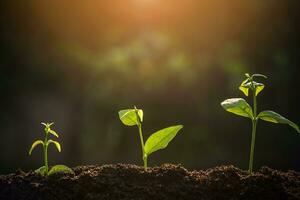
248, 88, 257, 173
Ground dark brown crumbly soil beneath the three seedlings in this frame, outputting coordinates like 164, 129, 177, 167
0, 164, 300, 200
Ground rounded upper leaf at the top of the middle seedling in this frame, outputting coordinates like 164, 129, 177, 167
119, 109, 143, 126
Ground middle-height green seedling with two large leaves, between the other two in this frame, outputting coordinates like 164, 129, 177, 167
119, 107, 183, 170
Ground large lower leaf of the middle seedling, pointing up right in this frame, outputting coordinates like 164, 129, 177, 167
145, 125, 183, 156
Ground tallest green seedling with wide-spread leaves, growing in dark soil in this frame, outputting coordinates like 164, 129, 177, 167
221, 73, 300, 173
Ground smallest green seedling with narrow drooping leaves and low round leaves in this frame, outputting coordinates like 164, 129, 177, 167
29, 123, 73, 176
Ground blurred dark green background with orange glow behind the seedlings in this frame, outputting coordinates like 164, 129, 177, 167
0, 0, 300, 174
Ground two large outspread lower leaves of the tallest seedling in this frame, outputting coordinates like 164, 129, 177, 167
221, 98, 300, 133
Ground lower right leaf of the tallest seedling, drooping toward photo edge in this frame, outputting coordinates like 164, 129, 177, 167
257, 110, 300, 133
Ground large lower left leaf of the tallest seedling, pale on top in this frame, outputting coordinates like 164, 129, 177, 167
221, 98, 253, 119
